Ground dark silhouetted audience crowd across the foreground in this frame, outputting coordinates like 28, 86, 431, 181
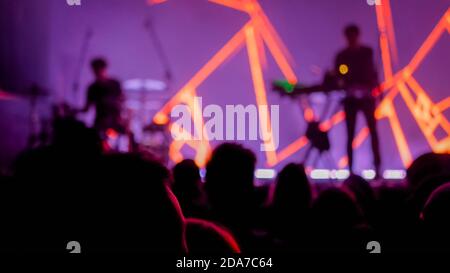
0, 120, 450, 254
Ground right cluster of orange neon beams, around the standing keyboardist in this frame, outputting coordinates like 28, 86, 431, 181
279, 0, 450, 167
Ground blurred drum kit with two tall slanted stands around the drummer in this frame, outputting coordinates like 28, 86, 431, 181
0, 16, 178, 162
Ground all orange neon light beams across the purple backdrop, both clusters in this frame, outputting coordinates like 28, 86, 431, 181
154, 0, 450, 167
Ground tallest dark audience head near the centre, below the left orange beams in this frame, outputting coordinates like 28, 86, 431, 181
205, 143, 256, 216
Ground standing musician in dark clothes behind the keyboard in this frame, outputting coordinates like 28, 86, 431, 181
334, 25, 381, 175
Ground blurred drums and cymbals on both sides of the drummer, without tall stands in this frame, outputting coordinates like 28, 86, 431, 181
0, 82, 170, 162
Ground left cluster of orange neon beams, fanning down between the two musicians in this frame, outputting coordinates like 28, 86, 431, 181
153, 0, 297, 164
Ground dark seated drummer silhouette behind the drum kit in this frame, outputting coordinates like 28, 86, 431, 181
81, 58, 126, 137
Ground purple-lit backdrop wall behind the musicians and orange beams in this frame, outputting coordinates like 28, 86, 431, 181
0, 0, 450, 172
